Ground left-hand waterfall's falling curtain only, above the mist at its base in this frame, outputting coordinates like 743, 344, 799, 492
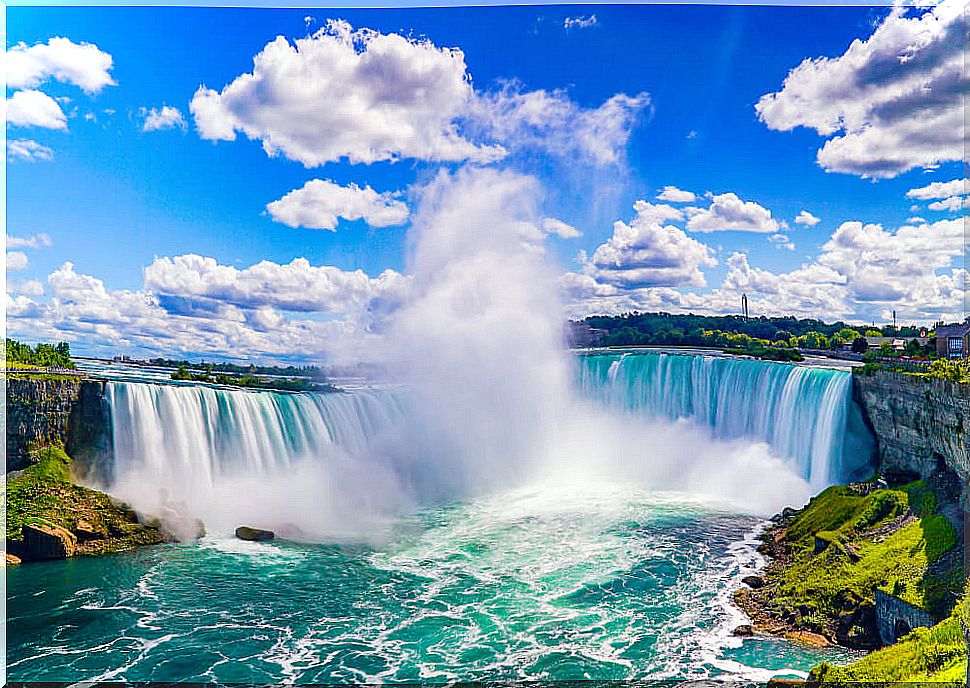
107, 382, 402, 488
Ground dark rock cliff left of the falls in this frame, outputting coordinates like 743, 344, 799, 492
6, 377, 111, 471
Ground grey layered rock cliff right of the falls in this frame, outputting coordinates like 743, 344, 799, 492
853, 372, 970, 498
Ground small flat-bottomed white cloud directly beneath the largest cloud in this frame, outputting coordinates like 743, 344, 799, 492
266, 179, 408, 230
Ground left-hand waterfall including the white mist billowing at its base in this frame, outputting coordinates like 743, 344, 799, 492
106, 382, 408, 539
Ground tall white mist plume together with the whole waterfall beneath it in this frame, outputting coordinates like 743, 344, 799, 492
98, 168, 864, 541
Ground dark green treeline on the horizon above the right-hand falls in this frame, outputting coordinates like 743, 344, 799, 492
582, 313, 920, 349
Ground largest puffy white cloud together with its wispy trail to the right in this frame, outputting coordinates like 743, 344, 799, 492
189, 21, 649, 167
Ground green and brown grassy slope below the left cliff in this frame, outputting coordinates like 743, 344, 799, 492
7, 446, 166, 554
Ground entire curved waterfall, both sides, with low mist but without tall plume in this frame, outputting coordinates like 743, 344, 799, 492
103, 353, 873, 538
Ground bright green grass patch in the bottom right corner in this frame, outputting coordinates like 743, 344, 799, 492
809, 584, 968, 686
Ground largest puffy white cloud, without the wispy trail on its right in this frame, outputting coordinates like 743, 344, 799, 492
189, 21, 504, 167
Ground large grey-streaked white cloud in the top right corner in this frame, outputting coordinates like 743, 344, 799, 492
756, 0, 968, 178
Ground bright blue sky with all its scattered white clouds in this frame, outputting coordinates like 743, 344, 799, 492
7, 2, 966, 358
